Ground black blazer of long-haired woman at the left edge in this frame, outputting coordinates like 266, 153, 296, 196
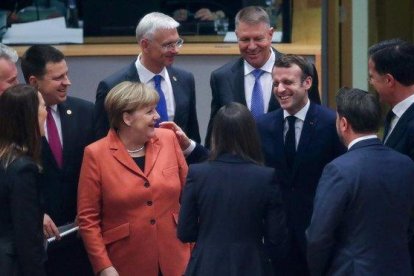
0, 157, 46, 275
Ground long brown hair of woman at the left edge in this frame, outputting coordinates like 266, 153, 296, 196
0, 84, 41, 167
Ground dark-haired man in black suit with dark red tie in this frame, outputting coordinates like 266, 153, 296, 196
22, 45, 93, 275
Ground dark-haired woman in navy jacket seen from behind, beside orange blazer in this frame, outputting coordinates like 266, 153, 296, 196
178, 103, 287, 276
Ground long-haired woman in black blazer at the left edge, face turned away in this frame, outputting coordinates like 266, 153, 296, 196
0, 84, 47, 275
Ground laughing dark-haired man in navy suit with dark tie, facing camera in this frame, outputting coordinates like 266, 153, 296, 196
257, 55, 345, 275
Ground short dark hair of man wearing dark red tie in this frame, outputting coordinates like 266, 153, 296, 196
21, 45, 65, 83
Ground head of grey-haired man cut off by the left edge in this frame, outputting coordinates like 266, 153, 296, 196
0, 43, 19, 95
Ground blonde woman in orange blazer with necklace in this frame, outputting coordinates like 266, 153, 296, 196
78, 82, 190, 276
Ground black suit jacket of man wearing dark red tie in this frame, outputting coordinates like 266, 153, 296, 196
41, 97, 93, 226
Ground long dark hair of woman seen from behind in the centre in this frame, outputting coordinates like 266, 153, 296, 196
210, 103, 263, 164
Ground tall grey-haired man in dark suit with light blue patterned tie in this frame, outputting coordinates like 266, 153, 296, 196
205, 6, 321, 146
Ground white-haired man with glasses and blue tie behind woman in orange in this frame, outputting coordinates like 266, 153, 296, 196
94, 12, 200, 142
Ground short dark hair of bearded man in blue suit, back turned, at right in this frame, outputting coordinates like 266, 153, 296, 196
336, 87, 381, 133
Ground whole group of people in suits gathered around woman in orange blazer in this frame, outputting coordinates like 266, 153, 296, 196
0, 6, 414, 276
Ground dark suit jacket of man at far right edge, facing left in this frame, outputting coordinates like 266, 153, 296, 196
385, 104, 414, 160
